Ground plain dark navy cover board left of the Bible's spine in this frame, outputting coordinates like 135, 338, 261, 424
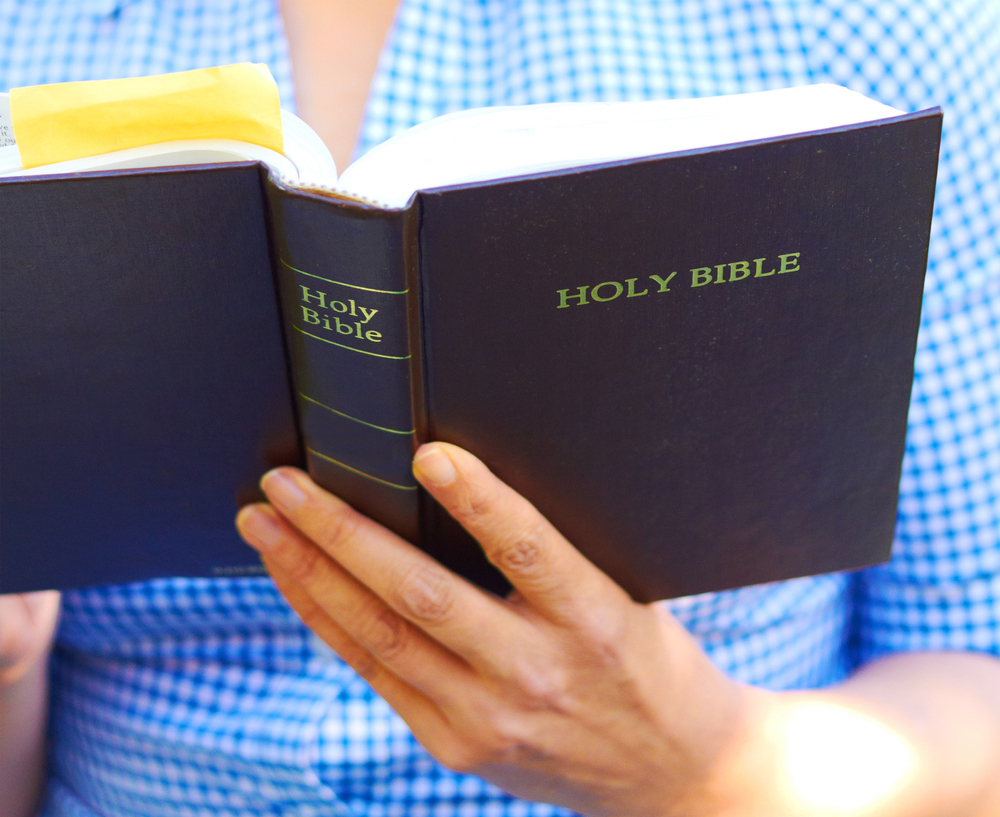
0, 165, 300, 592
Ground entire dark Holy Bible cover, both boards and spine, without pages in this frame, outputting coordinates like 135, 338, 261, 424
0, 111, 940, 600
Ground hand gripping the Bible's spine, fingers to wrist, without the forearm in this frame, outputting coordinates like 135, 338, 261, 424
238, 443, 759, 815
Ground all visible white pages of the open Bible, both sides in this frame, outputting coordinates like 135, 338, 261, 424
0, 85, 902, 207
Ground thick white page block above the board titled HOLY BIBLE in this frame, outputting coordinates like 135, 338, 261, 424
337, 85, 902, 207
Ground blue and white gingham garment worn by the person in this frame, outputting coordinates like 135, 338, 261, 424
0, 0, 1000, 817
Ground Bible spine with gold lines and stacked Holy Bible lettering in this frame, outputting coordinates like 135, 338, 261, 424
265, 179, 419, 541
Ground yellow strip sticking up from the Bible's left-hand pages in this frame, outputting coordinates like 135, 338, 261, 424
10, 63, 284, 170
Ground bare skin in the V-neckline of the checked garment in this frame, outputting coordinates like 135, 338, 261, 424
281, 0, 398, 171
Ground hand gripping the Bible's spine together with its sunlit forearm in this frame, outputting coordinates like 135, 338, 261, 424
238, 443, 1000, 817
